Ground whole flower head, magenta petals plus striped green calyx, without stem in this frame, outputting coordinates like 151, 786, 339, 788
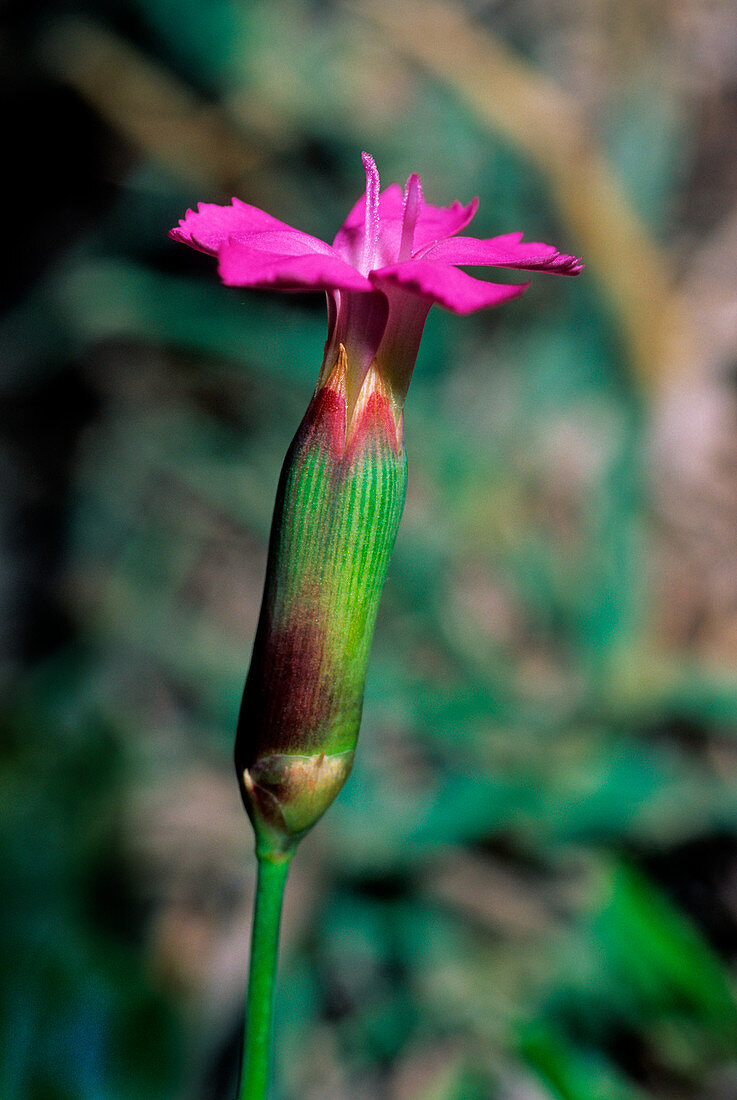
171, 153, 582, 856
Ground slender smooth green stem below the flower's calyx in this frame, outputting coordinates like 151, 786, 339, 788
238, 853, 292, 1100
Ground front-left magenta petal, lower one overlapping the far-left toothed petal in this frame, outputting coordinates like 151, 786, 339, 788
218, 240, 373, 292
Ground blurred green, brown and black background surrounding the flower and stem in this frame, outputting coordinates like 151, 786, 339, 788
0, 0, 737, 1100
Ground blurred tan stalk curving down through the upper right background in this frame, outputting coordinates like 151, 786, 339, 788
352, 0, 694, 392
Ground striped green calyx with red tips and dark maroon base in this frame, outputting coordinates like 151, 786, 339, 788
235, 344, 406, 854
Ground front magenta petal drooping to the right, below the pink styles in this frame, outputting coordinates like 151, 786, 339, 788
370, 260, 529, 314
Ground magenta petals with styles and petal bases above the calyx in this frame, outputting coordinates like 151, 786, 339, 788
169, 153, 583, 415
